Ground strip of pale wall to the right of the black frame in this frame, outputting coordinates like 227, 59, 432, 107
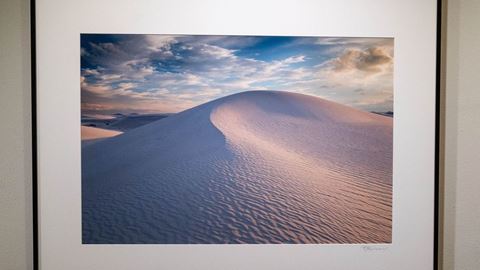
444, 0, 480, 270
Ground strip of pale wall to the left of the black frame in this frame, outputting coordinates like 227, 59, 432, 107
0, 0, 32, 270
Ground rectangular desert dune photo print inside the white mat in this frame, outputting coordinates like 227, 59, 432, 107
80, 34, 394, 244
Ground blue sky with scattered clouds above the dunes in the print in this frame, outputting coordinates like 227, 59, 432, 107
80, 34, 394, 115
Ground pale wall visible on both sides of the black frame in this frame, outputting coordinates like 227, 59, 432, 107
0, 0, 480, 270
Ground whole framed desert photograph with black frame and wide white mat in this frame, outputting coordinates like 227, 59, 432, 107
32, 0, 440, 270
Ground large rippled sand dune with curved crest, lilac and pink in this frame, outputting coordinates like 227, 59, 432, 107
82, 91, 393, 244
